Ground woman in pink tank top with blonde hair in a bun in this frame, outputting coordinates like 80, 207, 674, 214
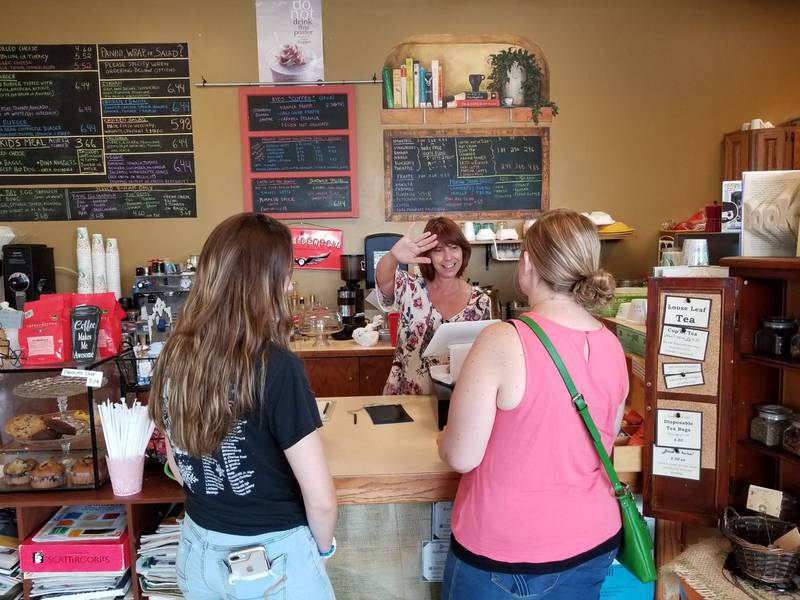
439, 209, 628, 600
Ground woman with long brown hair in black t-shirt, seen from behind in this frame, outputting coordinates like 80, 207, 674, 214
150, 213, 336, 600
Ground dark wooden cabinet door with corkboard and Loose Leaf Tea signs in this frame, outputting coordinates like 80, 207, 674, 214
642, 277, 739, 526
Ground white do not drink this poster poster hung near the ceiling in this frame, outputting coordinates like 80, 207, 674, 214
256, 0, 325, 83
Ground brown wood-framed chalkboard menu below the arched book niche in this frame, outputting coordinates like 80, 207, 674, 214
384, 127, 550, 221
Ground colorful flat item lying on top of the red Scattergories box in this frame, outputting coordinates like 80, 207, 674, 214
32, 504, 128, 542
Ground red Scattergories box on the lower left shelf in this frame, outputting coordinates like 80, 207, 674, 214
19, 531, 130, 573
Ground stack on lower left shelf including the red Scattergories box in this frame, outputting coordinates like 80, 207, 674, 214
19, 505, 131, 600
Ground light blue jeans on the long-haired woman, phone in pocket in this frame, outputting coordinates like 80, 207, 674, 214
175, 515, 335, 600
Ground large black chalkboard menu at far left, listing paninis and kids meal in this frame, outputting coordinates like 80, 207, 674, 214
0, 44, 197, 221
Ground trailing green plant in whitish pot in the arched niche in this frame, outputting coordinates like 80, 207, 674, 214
488, 47, 558, 123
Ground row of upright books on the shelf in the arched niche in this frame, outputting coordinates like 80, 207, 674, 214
383, 57, 444, 108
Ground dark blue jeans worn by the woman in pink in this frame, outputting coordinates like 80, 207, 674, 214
442, 550, 617, 600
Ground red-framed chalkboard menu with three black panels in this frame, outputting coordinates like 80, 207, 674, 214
240, 86, 358, 219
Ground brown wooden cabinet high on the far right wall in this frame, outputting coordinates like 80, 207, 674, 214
722, 127, 800, 181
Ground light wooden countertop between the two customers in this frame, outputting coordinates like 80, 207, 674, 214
322, 396, 460, 504
